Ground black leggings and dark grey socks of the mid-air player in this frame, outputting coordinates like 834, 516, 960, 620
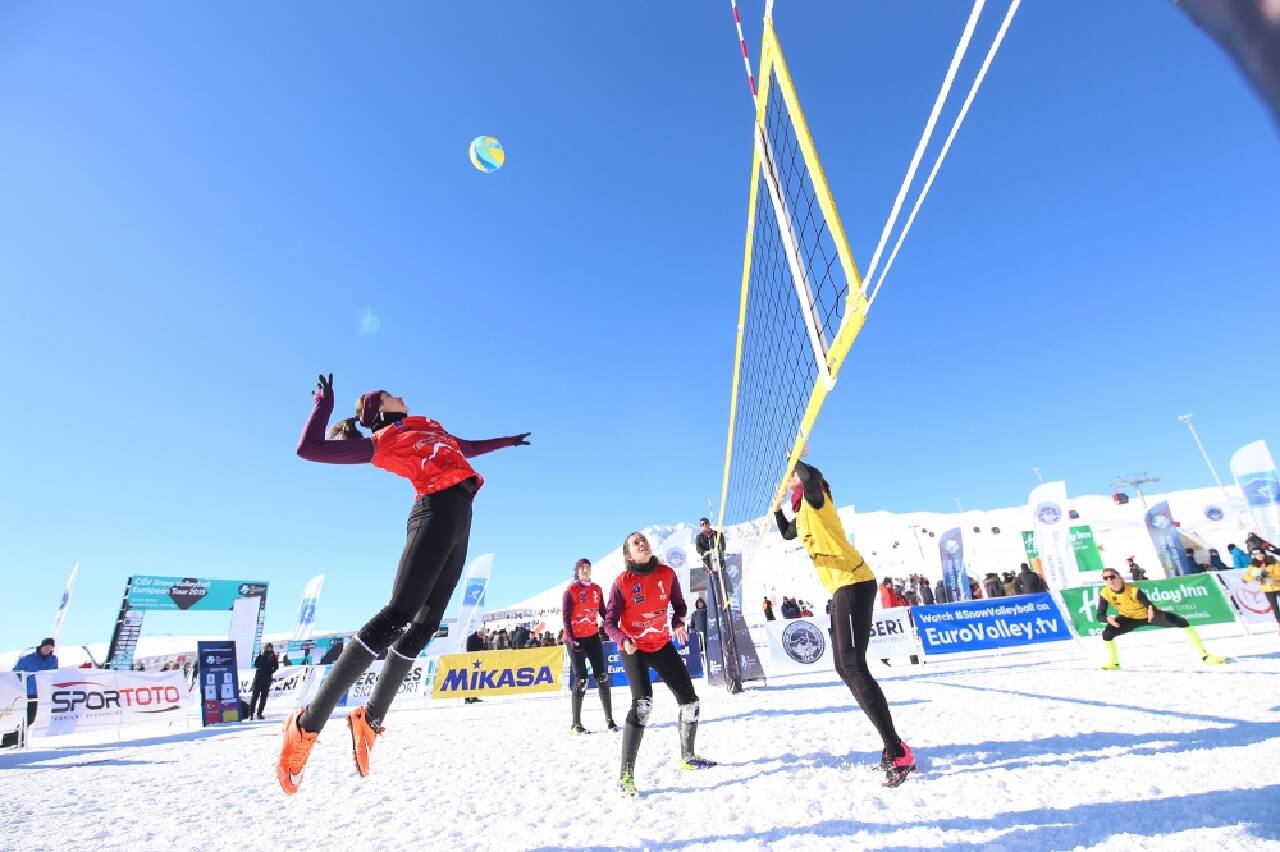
298, 480, 475, 733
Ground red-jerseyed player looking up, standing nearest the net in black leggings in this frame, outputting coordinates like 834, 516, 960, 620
604, 532, 716, 796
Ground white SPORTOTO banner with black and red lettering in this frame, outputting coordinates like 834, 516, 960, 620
31, 669, 189, 737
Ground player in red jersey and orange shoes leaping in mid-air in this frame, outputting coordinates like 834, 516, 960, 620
275, 374, 529, 796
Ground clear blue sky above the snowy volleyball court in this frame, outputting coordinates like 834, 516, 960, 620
0, 0, 1280, 647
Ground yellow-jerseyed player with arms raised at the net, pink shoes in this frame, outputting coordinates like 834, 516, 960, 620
774, 462, 915, 787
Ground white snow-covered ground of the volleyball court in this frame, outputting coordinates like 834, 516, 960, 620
0, 631, 1280, 852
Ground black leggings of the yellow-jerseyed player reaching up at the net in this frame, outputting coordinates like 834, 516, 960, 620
831, 580, 901, 757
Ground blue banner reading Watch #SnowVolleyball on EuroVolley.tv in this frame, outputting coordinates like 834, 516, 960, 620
911, 592, 1071, 654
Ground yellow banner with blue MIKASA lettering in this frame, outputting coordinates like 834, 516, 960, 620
431, 645, 564, 698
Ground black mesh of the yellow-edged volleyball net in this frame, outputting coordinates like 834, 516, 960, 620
724, 74, 849, 523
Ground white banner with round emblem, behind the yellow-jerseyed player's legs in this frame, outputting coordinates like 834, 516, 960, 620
764, 606, 920, 674
